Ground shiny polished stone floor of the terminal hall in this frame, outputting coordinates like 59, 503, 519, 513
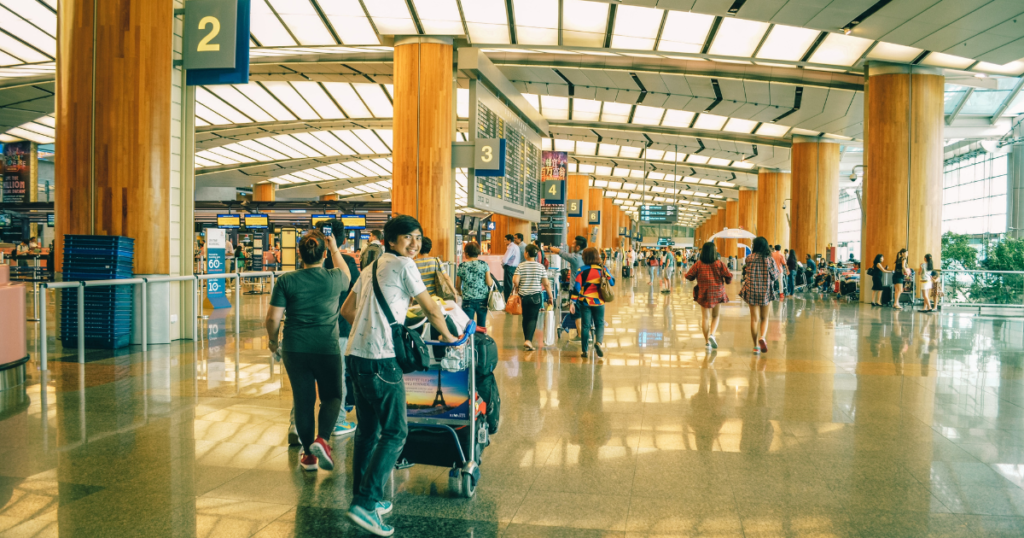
0, 266, 1024, 538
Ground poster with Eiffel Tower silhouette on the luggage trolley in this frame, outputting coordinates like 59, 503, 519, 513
404, 369, 469, 420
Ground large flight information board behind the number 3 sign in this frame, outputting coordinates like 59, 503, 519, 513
469, 80, 541, 222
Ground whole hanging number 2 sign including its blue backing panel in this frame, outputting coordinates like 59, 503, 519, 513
181, 0, 251, 86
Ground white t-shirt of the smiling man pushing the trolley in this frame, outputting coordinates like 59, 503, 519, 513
345, 252, 427, 359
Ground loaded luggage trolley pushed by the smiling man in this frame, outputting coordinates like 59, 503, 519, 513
398, 321, 489, 498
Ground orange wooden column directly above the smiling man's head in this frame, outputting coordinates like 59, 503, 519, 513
391, 36, 455, 259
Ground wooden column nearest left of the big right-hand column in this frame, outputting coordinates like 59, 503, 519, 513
790, 135, 840, 260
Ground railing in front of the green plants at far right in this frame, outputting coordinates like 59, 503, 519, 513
937, 270, 1024, 308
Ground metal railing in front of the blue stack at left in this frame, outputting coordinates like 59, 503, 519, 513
37, 271, 281, 371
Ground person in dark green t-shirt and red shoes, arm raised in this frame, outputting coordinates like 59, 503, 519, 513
264, 230, 351, 470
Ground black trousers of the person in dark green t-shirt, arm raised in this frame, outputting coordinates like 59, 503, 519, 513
281, 350, 342, 451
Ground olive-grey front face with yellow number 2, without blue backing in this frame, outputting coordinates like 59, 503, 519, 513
182, 0, 239, 70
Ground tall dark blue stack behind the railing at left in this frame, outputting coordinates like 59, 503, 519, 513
60, 235, 135, 349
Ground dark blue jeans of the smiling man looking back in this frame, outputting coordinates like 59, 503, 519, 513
347, 355, 409, 510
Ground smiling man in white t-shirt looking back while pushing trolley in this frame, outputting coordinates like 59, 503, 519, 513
339, 215, 457, 536
